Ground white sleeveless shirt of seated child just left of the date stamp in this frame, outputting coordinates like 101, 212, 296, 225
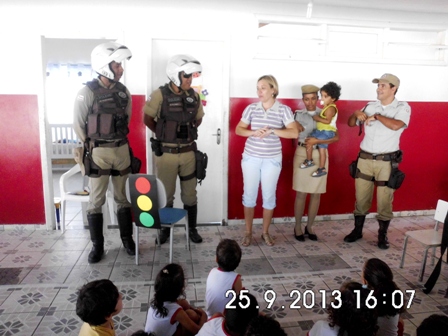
205, 267, 241, 318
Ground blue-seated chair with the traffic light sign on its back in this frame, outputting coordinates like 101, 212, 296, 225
126, 174, 190, 265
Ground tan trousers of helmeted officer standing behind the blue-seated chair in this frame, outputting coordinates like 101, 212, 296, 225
156, 151, 197, 207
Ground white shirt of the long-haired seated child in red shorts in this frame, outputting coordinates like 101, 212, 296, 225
145, 302, 182, 335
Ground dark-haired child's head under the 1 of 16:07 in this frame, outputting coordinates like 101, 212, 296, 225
328, 281, 378, 336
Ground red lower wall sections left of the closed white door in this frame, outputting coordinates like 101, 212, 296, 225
0, 95, 146, 224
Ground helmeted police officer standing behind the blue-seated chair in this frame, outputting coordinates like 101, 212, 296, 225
143, 55, 204, 244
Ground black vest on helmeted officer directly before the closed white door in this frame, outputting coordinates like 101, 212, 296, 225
156, 84, 200, 144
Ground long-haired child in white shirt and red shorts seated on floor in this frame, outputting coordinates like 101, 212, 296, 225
145, 264, 207, 336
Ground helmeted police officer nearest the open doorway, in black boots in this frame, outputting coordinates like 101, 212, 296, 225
73, 42, 135, 263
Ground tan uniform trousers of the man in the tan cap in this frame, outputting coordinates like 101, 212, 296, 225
354, 158, 395, 221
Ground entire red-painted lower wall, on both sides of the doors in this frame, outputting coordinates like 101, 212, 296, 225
0, 95, 448, 224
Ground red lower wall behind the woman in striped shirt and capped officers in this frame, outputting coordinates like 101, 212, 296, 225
228, 98, 448, 219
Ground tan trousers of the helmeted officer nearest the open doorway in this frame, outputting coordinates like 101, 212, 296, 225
87, 144, 131, 214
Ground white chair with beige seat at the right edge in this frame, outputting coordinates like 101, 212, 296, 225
400, 200, 448, 281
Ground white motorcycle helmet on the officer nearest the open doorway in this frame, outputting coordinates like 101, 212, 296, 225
91, 42, 132, 80
